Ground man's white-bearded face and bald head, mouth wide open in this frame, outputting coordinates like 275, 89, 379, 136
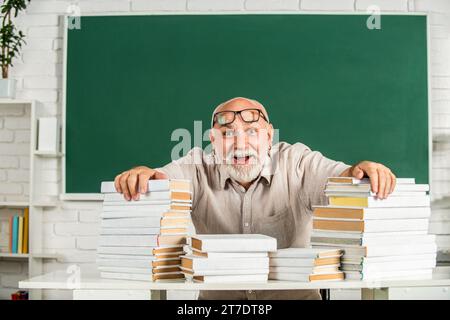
210, 98, 273, 183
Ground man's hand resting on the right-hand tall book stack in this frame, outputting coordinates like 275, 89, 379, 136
341, 161, 396, 199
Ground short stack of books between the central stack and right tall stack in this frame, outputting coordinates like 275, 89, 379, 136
269, 248, 344, 282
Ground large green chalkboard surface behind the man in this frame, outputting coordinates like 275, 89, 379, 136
65, 14, 429, 193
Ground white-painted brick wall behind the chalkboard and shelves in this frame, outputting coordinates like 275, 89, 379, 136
0, 0, 450, 299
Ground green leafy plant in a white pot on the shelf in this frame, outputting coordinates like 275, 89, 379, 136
0, 0, 30, 98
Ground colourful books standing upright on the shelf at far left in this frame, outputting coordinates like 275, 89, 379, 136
8, 208, 30, 254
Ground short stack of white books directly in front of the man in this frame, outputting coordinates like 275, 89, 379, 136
181, 234, 277, 283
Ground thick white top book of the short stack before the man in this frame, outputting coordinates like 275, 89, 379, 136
191, 234, 277, 252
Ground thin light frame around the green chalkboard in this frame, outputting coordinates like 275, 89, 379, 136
60, 11, 432, 201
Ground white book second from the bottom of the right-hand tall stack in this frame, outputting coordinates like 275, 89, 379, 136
341, 259, 436, 273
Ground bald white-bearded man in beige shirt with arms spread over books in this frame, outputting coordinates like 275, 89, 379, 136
115, 98, 395, 299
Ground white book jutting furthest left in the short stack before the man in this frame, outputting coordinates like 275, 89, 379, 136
181, 255, 269, 271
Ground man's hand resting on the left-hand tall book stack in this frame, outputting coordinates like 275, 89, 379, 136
114, 166, 167, 201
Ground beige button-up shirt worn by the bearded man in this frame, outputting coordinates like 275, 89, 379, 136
157, 142, 349, 299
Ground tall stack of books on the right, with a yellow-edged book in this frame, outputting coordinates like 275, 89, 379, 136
311, 177, 436, 281
